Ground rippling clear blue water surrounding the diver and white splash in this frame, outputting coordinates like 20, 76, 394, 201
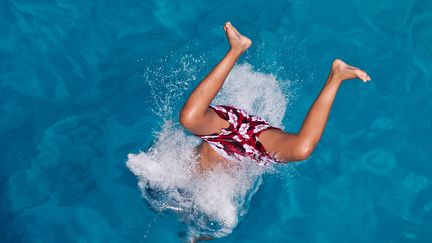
0, 0, 432, 243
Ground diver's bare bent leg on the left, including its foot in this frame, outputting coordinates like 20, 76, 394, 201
180, 22, 252, 134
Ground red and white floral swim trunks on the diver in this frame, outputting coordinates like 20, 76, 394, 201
196, 105, 281, 165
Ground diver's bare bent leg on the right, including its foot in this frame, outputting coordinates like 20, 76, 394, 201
260, 59, 370, 162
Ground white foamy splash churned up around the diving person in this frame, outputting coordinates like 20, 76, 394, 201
127, 59, 287, 237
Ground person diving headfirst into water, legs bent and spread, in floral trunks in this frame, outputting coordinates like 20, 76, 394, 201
179, 22, 371, 170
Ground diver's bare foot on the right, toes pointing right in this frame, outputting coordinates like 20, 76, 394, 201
330, 59, 371, 83
